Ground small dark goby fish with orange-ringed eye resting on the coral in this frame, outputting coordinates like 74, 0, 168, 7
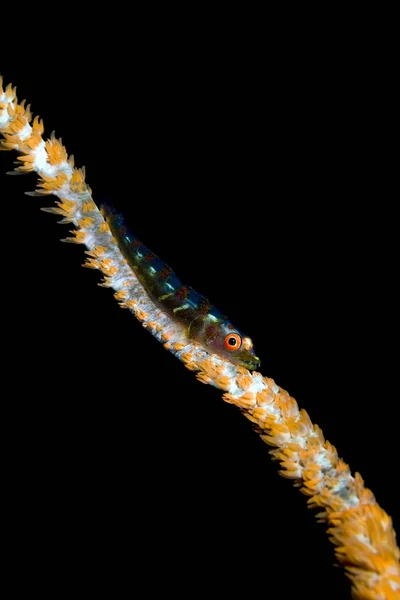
101, 205, 260, 370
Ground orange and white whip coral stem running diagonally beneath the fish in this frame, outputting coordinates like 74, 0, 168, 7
0, 77, 400, 600
